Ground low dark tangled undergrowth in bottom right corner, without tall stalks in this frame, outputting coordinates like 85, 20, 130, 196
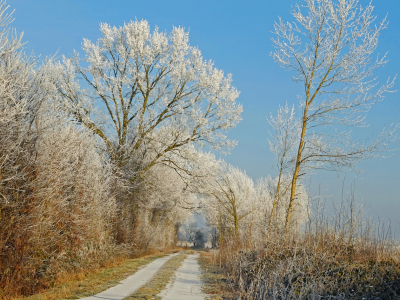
222, 237, 400, 299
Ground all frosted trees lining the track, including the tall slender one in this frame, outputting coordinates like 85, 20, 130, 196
0, 0, 395, 294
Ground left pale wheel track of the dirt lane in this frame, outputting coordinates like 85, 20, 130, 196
81, 253, 178, 300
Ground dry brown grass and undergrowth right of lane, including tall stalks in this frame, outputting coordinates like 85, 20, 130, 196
209, 198, 400, 300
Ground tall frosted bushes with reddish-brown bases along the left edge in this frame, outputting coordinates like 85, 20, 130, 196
0, 7, 116, 295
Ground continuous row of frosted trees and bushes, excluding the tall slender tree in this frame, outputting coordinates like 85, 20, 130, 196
0, 2, 308, 296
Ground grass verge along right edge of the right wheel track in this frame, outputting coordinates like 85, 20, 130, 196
199, 250, 238, 300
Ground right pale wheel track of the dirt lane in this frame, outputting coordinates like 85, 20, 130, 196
159, 254, 206, 300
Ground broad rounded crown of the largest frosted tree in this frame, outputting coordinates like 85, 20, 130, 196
52, 21, 242, 178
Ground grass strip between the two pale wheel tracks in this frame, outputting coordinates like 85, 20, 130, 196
124, 251, 188, 300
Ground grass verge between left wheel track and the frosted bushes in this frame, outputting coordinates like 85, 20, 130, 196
14, 253, 175, 300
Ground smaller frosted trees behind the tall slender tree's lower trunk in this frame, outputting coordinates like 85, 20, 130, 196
200, 155, 309, 245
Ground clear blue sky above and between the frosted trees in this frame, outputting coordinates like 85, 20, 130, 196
8, 0, 400, 232
